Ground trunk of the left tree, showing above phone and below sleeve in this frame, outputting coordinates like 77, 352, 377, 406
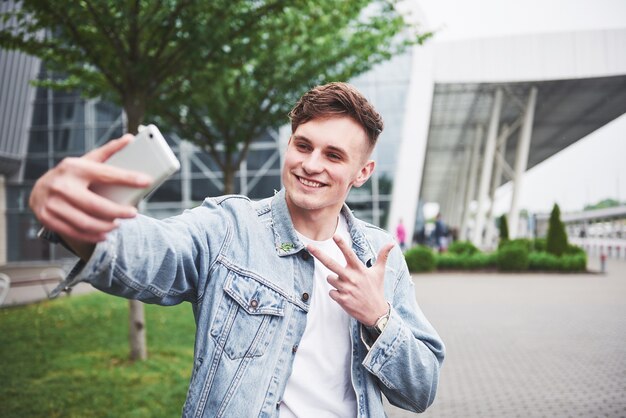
124, 99, 148, 361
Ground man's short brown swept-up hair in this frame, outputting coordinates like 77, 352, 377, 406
289, 82, 383, 147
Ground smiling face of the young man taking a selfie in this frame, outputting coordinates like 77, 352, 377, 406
282, 117, 374, 217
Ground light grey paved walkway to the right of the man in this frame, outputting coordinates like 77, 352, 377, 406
387, 260, 626, 418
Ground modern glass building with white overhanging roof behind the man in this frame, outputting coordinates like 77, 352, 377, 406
0, 2, 626, 265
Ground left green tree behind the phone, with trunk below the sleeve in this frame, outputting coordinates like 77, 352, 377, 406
0, 0, 284, 360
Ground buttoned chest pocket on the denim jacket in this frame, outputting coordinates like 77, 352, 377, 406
210, 271, 285, 359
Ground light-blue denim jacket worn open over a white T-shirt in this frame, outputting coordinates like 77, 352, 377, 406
50, 190, 444, 418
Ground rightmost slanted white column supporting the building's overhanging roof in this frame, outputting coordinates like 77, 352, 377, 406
509, 87, 537, 239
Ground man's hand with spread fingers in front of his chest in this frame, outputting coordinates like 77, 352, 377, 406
307, 235, 394, 326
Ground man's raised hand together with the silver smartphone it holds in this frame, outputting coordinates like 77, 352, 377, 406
29, 125, 180, 260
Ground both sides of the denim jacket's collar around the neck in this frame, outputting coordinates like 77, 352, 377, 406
270, 188, 375, 266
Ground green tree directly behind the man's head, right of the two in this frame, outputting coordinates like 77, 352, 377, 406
157, 0, 430, 194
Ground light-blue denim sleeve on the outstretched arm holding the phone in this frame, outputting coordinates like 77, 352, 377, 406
56, 206, 228, 305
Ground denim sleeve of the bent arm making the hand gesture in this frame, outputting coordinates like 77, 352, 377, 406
363, 250, 445, 412
